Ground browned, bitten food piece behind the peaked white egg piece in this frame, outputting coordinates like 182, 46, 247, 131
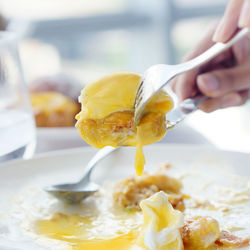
113, 173, 185, 211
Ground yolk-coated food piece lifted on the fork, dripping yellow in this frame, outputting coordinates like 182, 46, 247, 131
76, 73, 173, 175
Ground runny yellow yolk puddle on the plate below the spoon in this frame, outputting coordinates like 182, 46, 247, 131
35, 213, 138, 250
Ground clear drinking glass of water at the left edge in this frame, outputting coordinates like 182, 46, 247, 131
0, 31, 36, 162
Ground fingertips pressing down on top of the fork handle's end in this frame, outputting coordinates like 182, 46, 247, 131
213, 0, 250, 42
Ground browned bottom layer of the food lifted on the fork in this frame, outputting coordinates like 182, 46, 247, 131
78, 111, 165, 148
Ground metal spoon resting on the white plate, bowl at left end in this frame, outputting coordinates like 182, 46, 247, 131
44, 146, 117, 203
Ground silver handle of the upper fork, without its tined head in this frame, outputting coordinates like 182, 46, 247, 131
180, 28, 250, 72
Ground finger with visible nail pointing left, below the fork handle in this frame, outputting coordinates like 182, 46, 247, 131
197, 63, 250, 98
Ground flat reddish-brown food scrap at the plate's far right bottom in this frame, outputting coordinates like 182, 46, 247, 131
216, 231, 250, 247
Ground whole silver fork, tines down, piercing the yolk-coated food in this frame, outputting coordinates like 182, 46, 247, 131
134, 28, 250, 125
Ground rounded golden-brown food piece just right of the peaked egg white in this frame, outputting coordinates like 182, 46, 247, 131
181, 217, 220, 250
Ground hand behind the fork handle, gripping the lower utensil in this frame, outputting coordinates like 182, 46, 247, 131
172, 22, 250, 112
